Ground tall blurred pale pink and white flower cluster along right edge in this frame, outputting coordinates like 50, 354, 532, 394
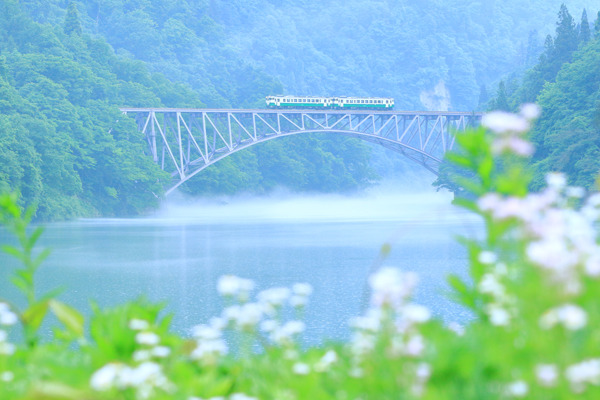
475, 105, 600, 398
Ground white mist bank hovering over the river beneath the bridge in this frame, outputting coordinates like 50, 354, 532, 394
154, 180, 468, 224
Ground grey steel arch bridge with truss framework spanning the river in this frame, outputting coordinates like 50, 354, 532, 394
121, 108, 482, 195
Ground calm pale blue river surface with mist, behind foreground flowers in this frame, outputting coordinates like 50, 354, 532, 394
0, 186, 480, 342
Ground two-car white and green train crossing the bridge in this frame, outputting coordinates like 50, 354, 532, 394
266, 95, 394, 110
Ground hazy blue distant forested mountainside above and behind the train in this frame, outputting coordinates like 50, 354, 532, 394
21, 0, 592, 110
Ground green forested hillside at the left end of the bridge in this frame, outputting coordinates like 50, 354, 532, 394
0, 0, 202, 219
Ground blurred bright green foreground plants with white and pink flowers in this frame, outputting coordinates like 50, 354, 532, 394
0, 105, 600, 400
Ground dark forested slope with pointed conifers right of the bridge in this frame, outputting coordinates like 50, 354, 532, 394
489, 6, 600, 189
